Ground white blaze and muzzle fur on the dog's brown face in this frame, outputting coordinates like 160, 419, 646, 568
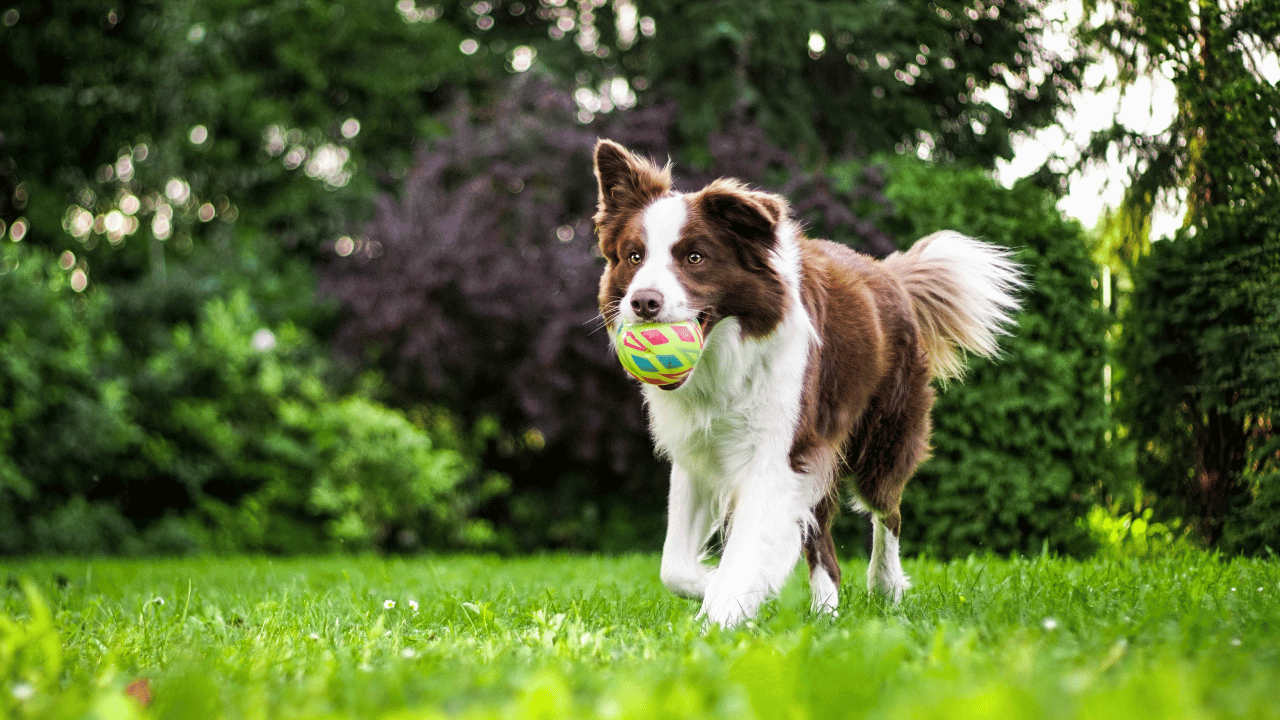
622, 195, 698, 323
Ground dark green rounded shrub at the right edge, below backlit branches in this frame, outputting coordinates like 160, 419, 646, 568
1117, 205, 1280, 552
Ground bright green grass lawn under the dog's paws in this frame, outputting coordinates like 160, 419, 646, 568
0, 553, 1280, 720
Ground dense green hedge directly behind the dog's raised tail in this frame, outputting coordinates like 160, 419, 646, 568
870, 159, 1117, 557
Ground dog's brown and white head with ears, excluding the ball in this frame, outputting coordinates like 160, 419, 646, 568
595, 140, 787, 337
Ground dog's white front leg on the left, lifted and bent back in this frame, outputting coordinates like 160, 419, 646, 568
659, 462, 714, 600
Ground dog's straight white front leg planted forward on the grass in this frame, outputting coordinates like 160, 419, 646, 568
699, 461, 808, 628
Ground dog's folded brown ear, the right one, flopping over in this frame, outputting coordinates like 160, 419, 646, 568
696, 179, 787, 266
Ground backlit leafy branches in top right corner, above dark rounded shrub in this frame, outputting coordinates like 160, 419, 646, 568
1080, 0, 1280, 222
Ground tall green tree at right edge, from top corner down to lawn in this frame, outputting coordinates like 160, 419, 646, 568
1083, 0, 1280, 540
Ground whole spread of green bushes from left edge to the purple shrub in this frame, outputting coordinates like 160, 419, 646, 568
0, 243, 494, 553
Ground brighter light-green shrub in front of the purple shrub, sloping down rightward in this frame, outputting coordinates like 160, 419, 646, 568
123, 292, 499, 552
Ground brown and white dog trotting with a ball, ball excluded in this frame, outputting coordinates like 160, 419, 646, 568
595, 140, 1023, 626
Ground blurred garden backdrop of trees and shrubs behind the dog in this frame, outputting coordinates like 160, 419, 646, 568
0, 0, 1280, 557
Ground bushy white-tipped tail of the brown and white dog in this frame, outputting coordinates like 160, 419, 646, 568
884, 231, 1027, 380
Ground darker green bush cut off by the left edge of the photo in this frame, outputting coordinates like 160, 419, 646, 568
0, 242, 140, 553
